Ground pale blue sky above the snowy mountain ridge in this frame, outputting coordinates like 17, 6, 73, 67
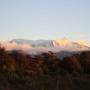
0, 0, 90, 42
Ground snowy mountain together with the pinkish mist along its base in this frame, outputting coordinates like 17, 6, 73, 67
2, 38, 90, 54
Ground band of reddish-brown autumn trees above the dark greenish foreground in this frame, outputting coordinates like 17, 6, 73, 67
0, 48, 90, 74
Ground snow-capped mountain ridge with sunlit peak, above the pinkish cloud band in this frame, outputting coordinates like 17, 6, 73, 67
10, 38, 89, 48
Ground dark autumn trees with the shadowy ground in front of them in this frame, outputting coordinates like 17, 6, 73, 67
0, 48, 90, 90
